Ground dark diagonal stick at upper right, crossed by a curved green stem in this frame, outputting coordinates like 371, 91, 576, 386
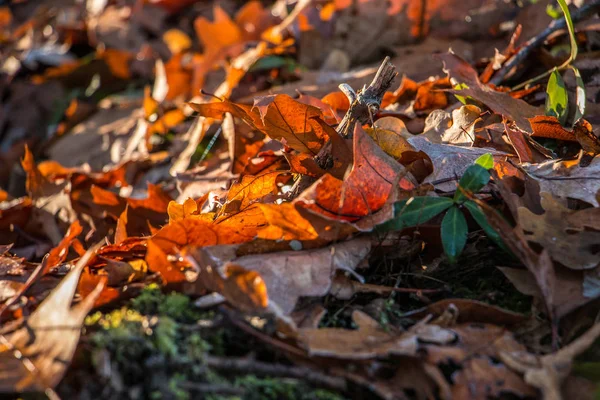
490, 0, 600, 85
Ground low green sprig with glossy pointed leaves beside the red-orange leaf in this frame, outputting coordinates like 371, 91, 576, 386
378, 154, 504, 262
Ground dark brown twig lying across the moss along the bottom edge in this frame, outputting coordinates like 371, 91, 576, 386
205, 356, 347, 391
